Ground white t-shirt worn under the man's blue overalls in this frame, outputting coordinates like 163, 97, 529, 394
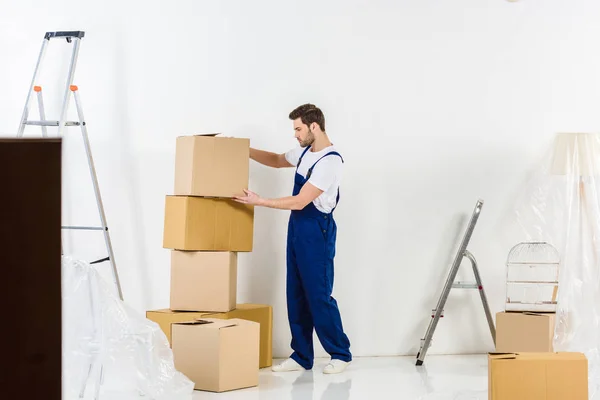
285, 146, 344, 214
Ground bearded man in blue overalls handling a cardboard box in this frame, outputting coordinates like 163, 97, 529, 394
235, 104, 352, 374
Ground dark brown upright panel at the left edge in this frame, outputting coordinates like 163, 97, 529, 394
0, 139, 62, 400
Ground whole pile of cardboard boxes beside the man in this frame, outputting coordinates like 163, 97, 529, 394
146, 134, 273, 392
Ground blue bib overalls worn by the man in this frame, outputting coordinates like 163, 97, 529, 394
287, 146, 352, 369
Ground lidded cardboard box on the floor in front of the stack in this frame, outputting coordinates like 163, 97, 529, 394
171, 318, 260, 392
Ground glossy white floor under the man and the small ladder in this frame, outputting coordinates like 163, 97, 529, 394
194, 355, 488, 400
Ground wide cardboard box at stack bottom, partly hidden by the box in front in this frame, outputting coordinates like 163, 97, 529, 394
146, 304, 273, 368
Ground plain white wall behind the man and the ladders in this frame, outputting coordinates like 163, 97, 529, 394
0, 0, 600, 356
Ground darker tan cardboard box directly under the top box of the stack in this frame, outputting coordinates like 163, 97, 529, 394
163, 196, 254, 252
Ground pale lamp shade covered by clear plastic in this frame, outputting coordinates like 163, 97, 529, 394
551, 133, 600, 176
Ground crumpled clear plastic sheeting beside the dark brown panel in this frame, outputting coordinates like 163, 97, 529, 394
62, 257, 194, 400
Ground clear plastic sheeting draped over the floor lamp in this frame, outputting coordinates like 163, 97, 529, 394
511, 133, 600, 400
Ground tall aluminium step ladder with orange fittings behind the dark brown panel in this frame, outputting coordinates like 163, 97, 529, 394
17, 31, 123, 300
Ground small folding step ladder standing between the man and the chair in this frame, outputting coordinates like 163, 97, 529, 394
417, 200, 496, 365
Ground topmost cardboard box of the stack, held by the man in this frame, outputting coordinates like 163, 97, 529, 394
174, 134, 250, 198
